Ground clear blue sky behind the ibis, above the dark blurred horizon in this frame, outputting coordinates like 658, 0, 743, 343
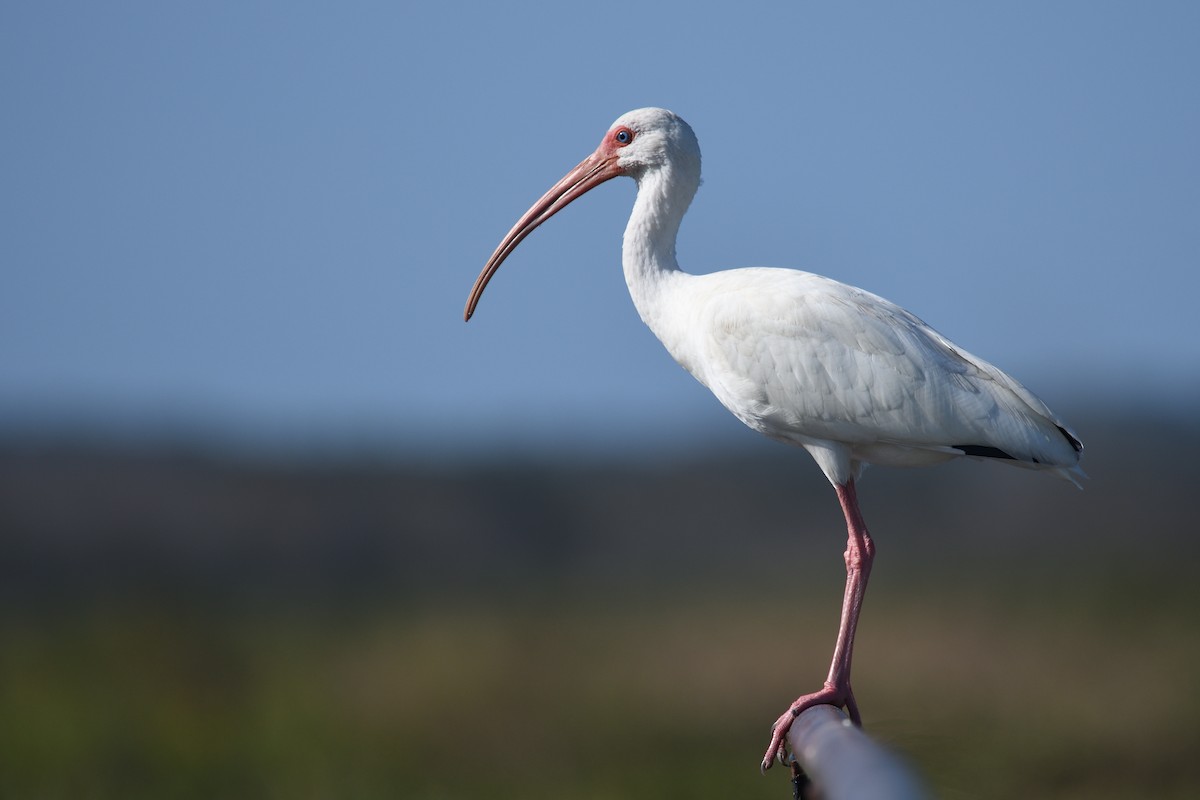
0, 2, 1200, 449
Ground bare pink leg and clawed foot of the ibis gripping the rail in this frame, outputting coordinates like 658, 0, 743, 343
762, 479, 875, 772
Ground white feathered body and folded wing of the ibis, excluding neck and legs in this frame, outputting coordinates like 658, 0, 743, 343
662, 269, 1082, 481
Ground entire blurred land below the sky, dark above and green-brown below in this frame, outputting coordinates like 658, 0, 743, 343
0, 414, 1200, 799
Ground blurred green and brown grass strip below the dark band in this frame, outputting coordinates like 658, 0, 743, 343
0, 581, 1200, 799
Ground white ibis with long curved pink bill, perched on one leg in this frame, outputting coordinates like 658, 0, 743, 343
464, 108, 1084, 770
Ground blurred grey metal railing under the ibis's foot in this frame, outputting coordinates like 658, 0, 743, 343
787, 705, 932, 800
